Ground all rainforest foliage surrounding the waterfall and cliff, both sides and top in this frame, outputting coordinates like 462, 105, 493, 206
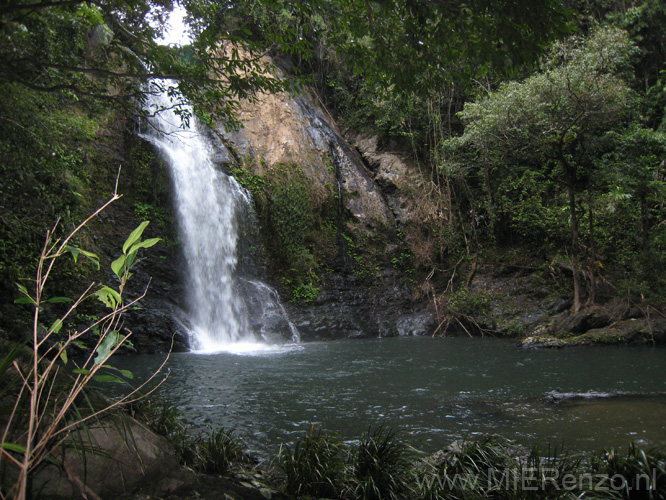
0, 0, 666, 308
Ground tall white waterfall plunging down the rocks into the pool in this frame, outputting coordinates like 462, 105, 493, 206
140, 82, 298, 351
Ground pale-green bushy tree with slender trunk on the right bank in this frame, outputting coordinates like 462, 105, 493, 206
452, 28, 634, 311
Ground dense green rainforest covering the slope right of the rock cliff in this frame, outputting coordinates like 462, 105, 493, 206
218, 0, 666, 304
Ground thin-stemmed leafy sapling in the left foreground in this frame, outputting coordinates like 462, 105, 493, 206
0, 194, 166, 500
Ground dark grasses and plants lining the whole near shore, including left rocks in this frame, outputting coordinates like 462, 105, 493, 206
5, 380, 666, 500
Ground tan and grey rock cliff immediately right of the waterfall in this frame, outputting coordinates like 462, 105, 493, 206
210, 81, 436, 340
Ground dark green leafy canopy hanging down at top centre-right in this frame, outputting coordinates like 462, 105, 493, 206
322, 0, 569, 95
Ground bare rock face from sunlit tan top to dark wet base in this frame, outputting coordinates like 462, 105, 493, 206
208, 71, 437, 341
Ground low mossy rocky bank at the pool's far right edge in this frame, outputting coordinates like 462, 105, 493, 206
434, 262, 666, 348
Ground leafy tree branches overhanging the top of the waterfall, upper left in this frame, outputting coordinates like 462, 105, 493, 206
0, 0, 282, 125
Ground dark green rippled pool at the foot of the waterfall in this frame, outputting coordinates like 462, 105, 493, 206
114, 338, 666, 454
